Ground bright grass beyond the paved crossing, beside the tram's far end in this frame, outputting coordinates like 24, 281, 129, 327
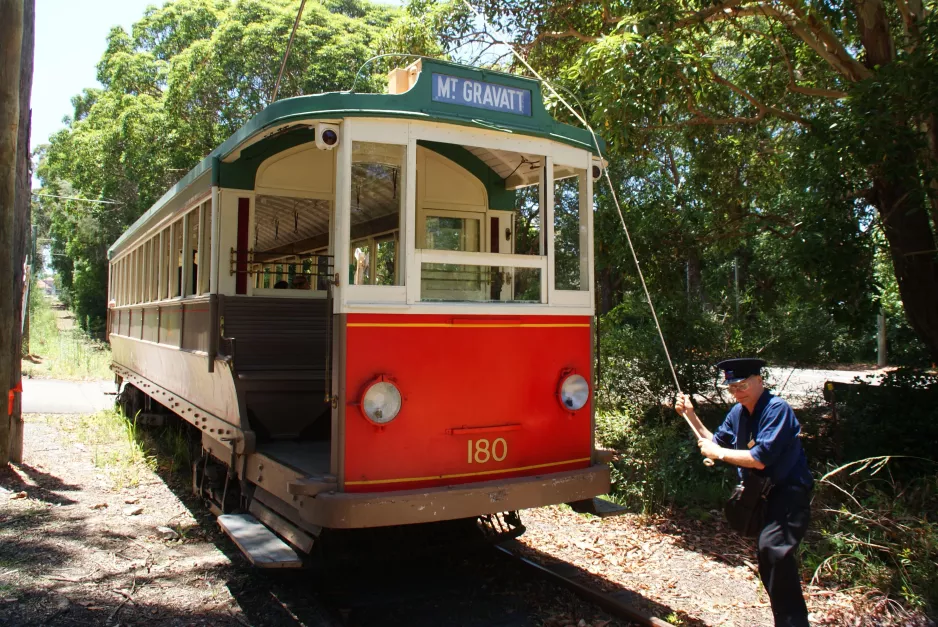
23, 290, 113, 380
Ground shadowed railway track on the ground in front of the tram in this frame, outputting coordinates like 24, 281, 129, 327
229, 541, 670, 627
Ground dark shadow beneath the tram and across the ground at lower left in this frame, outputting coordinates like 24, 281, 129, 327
0, 412, 703, 627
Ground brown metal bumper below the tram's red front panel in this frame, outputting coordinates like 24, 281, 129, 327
301, 464, 609, 529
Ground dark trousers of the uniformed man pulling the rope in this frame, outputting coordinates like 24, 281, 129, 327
759, 486, 811, 627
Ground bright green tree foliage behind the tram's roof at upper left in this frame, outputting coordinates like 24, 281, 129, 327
37, 0, 402, 330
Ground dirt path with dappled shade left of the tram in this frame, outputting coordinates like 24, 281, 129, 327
0, 416, 246, 625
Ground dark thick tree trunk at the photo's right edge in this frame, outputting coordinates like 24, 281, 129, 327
873, 177, 938, 361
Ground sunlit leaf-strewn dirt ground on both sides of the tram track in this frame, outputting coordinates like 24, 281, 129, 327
0, 415, 904, 627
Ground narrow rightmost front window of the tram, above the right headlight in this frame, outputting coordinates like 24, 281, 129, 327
554, 170, 589, 291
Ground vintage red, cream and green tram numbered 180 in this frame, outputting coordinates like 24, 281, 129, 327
108, 59, 610, 566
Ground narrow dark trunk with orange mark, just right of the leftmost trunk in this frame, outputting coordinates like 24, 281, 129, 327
10, 0, 36, 462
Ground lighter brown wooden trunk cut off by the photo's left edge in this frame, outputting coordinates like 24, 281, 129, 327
0, 0, 23, 468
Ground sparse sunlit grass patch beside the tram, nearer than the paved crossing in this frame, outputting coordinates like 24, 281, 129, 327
41, 409, 156, 490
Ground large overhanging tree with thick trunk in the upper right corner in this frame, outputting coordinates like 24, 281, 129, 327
420, 0, 938, 358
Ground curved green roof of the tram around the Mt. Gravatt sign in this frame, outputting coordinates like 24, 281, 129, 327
108, 59, 605, 258
